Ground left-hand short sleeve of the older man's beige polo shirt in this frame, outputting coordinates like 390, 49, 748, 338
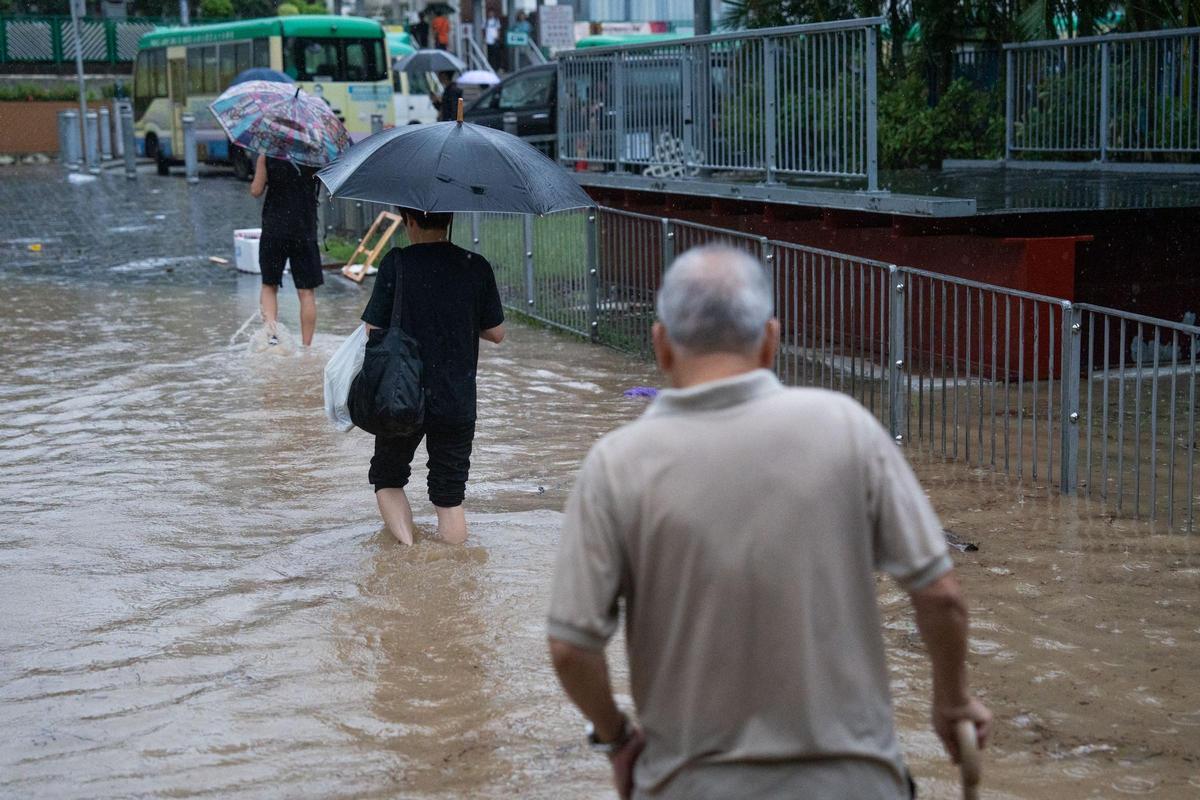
547, 449, 625, 650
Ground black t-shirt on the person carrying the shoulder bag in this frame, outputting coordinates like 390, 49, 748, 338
362, 242, 504, 422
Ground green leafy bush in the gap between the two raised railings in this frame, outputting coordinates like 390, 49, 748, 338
878, 74, 1004, 169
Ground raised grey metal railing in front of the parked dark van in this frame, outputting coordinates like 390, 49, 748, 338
558, 18, 882, 191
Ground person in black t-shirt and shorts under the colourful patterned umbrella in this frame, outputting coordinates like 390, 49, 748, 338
250, 155, 325, 347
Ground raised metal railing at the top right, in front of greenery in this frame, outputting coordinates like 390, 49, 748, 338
1004, 28, 1200, 161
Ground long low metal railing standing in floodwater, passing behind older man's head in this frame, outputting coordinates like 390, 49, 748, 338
326, 201, 1200, 531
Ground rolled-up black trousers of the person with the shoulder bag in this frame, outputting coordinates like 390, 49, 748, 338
367, 421, 475, 509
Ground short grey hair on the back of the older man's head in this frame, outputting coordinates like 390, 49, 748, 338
656, 245, 774, 355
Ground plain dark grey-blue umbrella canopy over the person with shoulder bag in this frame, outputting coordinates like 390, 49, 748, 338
317, 122, 595, 215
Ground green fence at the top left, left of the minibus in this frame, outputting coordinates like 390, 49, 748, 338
0, 17, 163, 66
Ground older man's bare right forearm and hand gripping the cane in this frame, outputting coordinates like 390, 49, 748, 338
912, 571, 991, 763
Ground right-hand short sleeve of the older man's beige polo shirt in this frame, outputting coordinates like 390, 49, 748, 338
863, 411, 954, 593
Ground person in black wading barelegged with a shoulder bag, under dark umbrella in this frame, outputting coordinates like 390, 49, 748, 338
362, 209, 504, 545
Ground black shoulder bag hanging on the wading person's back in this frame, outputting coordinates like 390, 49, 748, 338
347, 258, 425, 437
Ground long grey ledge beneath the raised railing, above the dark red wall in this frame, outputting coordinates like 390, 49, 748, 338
575, 173, 976, 217
